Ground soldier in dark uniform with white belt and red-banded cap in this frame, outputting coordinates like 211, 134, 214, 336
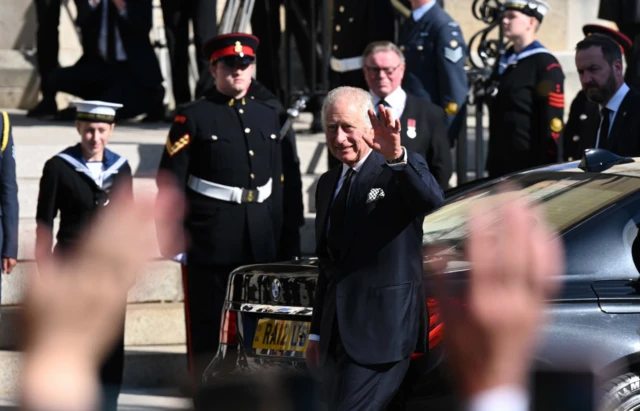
157, 33, 283, 383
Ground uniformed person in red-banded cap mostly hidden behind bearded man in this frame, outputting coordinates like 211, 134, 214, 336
562, 24, 633, 161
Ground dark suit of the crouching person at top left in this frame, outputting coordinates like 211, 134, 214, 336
50, 0, 162, 118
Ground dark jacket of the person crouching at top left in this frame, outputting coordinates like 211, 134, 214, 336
76, 0, 162, 88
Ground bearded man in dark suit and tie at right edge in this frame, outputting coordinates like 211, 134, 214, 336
576, 34, 640, 157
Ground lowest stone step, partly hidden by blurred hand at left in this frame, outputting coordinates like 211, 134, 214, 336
0, 345, 189, 396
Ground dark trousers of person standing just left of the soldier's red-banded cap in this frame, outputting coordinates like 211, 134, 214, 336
160, 0, 217, 105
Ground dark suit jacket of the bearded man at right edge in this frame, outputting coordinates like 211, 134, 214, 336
601, 89, 640, 157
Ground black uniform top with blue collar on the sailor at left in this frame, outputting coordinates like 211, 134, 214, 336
36, 144, 133, 251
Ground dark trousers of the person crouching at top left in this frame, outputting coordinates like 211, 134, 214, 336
50, 57, 155, 119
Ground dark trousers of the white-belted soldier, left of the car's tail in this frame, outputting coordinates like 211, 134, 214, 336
182, 262, 237, 385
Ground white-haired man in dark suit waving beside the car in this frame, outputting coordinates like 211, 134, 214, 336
305, 87, 443, 410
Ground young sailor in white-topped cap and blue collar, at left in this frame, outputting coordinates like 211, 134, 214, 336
36, 101, 133, 410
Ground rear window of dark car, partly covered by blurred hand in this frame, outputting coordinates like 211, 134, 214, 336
423, 172, 640, 248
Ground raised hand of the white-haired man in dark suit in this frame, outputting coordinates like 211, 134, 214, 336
363, 104, 402, 161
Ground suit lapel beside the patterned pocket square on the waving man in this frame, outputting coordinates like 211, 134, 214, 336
342, 152, 385, 257
